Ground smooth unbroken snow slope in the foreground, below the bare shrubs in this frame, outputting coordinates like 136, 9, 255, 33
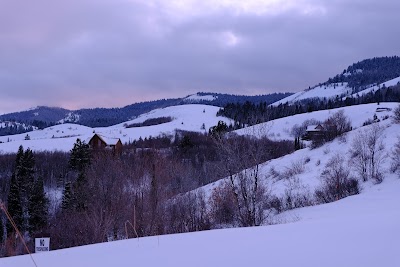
0, 178, 400, 267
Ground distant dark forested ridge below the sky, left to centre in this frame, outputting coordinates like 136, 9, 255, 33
0, 92, 291, 135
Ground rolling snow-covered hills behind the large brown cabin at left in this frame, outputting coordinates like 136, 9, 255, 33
0, 104, 231, 153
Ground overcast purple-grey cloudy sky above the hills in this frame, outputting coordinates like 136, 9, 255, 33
0, 0, 400, 113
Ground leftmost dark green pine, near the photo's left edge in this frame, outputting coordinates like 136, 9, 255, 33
6, 174, 25, 236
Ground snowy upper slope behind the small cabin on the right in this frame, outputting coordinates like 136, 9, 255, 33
235, 103, 399, 140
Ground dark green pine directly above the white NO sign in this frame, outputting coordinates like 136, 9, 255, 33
28, 178, 49, 234
